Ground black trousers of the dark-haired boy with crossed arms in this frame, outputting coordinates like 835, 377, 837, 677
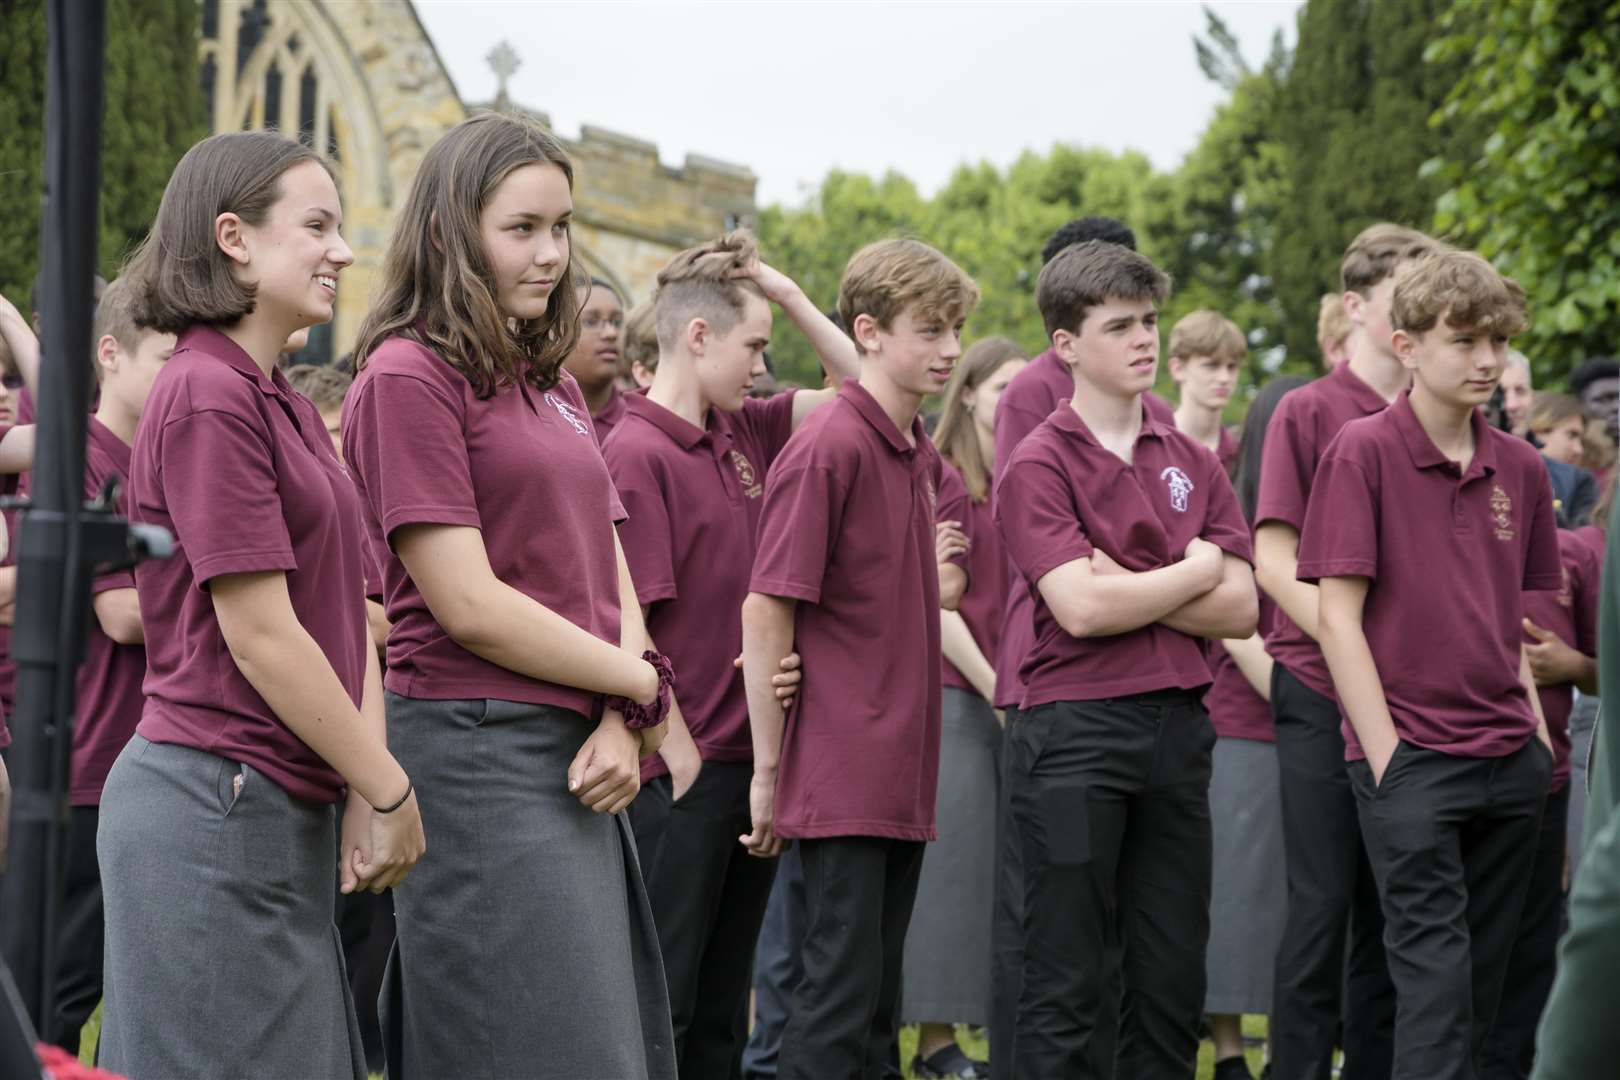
1008, 690, 1215, 1080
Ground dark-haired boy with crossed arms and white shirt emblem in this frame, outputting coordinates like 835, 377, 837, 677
995, 241, 1257, 1080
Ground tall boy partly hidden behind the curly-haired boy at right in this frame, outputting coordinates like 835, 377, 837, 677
1254, 223, 1440, 1080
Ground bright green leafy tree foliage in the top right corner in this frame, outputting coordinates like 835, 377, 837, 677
1427, 0, 1620, 382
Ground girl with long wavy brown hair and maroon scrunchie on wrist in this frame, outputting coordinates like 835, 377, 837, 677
342, 113, 676, 1080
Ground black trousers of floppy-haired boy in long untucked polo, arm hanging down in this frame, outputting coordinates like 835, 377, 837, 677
778, 836, 923, 1080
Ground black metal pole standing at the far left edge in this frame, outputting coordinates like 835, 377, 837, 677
0, 0, 105, 1049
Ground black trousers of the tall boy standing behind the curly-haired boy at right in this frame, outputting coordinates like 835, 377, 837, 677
1270, 664, 1395, 1080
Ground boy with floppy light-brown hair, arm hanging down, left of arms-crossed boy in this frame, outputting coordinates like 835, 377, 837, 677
742, 240, 978, 1080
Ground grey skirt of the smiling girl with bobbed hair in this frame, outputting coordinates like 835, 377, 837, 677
96, 735, 366, 1080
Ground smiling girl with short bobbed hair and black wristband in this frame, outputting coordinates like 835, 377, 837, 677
97, 131, 424, 1080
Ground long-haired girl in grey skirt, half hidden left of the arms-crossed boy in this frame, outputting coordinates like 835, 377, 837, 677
901, 337, 1029, 1077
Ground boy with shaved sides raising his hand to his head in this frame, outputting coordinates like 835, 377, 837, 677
603, 232, 857, 1080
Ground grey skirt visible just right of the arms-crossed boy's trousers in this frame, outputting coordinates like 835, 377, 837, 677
1204, 738, 1288, 1015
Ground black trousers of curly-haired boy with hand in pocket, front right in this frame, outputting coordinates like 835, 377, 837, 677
1348, 738, 1552, 1080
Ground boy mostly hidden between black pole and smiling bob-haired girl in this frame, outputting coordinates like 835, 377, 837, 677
57, 280, 175, 1052
